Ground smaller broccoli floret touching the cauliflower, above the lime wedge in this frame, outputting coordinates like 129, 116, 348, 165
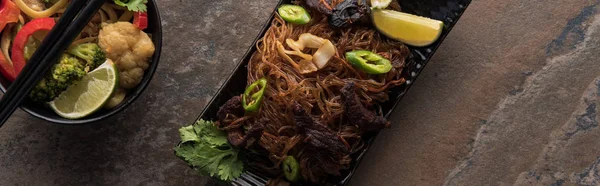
67, 43, 106, 71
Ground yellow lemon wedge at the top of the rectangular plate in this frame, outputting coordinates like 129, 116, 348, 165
371, 9, 444, 47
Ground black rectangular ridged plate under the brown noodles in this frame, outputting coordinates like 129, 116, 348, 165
198, 0, 471, 186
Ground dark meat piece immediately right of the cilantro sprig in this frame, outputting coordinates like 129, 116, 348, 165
227, 118, 270, 148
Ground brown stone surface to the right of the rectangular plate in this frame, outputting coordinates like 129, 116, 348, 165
352, 0, 600, 186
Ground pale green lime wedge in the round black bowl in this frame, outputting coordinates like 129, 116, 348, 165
49, 60, 119, 119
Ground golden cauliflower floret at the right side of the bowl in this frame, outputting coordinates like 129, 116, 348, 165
98, 22, 155, 89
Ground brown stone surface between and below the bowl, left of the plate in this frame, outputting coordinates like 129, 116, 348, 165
0, 0, 277, 186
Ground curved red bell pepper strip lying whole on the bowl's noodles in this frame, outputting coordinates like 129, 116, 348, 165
11, 18, 56, 74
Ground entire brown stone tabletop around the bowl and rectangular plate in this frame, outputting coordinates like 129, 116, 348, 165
5, 0, 600, 186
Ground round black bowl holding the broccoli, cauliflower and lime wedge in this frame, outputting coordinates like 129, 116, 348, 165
0, 0, 162, 125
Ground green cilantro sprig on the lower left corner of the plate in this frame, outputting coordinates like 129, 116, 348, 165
175, 120, 244, 182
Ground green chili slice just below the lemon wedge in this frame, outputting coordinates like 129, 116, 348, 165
346, 50, 392, 74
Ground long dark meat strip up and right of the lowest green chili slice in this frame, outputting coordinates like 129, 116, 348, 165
293, 103, 349, 154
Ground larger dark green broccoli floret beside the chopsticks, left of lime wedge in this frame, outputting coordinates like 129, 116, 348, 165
29, 54, 87, 103
